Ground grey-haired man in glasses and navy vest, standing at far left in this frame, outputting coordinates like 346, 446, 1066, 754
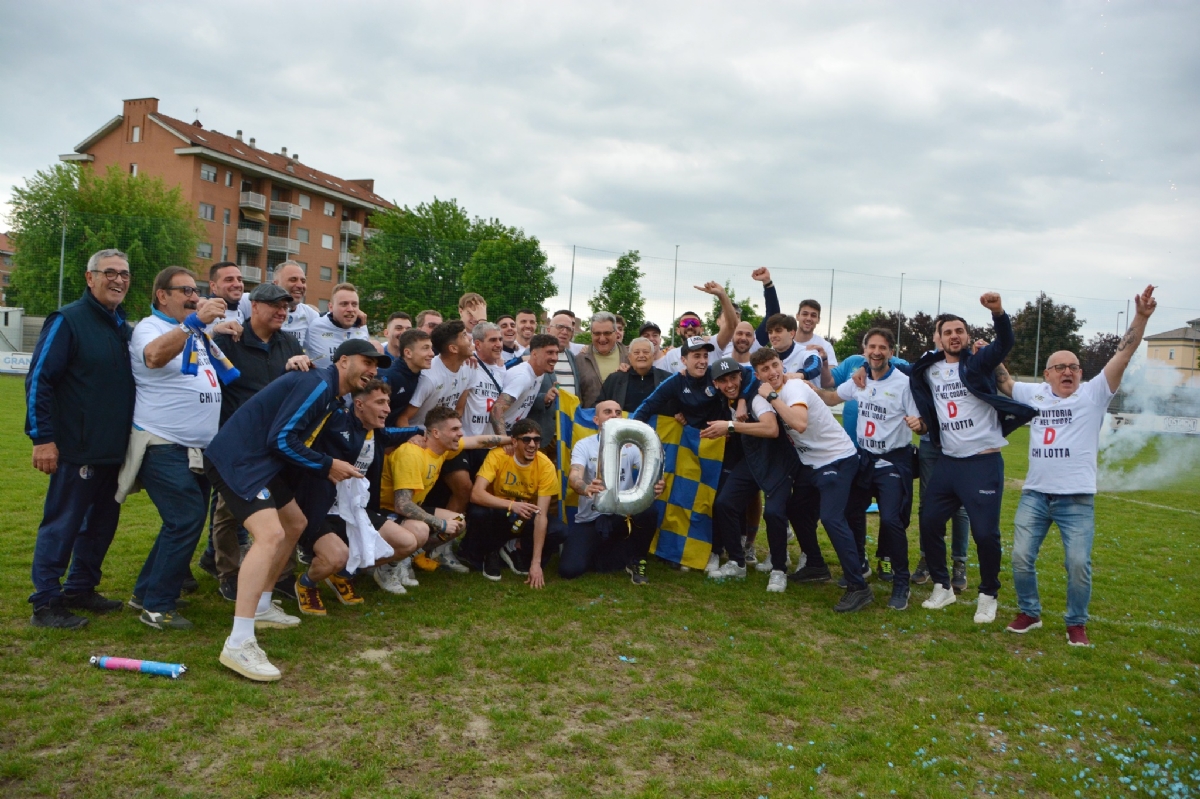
25, 250, 136, 630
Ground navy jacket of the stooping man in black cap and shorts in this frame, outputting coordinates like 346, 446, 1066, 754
204, 365, 342, 500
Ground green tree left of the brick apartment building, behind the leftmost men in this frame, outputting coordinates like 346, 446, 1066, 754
8, 164, 204, 319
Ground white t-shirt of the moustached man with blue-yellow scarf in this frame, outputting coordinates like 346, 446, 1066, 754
131, 316, 221, 449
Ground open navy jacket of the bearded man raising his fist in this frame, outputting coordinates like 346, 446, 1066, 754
908, 313, 1038, 449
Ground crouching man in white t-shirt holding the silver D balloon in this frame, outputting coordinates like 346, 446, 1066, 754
558, 400, 664, 585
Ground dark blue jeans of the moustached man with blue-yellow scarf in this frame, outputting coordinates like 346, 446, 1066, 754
133, 444, 209, 613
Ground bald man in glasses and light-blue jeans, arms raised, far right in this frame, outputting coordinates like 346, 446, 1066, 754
996, 286, 1158, 647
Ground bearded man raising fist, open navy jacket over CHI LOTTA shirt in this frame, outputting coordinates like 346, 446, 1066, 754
910, 292, 1037, 624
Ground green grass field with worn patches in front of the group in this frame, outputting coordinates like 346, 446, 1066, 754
0, 378, 1200, 799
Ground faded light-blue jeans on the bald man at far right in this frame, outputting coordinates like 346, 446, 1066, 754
1013, 491, 1096, 626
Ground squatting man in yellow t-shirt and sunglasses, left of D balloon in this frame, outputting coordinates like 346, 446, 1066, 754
461, 419, 564, 588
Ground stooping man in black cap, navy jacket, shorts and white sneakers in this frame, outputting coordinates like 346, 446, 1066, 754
204, 338, 391, 681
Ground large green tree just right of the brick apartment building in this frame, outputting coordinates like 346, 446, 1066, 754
350, 198, 558, 326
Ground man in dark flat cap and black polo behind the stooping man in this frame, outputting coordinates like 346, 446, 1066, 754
208, 283, 312, 601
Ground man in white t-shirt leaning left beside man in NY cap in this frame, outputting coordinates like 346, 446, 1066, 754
750, 347, 875, 613
